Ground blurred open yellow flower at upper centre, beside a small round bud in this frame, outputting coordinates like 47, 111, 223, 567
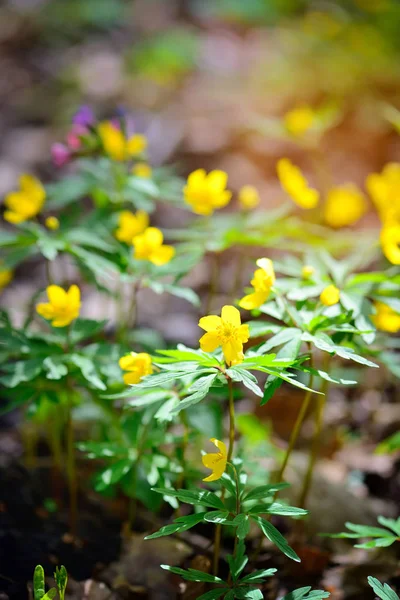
183, 169, 232, 215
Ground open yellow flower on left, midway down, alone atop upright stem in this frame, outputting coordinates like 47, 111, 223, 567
36, 285, 81, 327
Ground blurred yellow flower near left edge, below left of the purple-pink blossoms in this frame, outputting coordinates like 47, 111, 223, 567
4, 175, 46, 224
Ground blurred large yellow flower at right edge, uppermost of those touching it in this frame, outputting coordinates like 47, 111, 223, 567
366, 162, 400, 224
